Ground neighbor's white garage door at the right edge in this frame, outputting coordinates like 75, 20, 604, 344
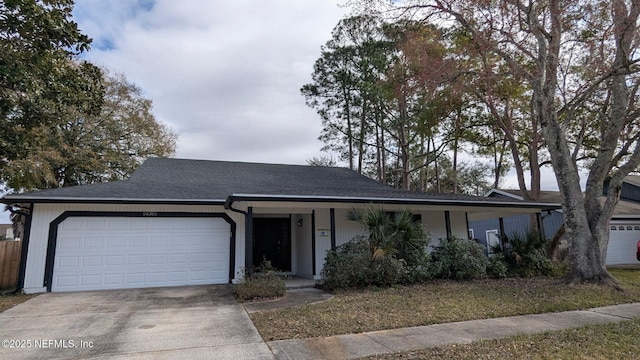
607, 223, 640, 265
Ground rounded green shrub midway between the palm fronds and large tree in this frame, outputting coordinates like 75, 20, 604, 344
431, 237, 489, 280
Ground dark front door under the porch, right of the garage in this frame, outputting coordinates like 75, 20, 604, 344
253, 218, 291, 271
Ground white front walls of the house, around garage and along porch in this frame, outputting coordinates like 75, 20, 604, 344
24, 202, 480, 292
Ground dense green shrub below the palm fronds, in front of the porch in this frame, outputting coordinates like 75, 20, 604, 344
320, 236, 407, 291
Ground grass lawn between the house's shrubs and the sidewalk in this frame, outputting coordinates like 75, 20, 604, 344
251, 268, 640, 341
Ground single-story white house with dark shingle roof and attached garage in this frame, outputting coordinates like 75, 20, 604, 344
2, 158, 558, 293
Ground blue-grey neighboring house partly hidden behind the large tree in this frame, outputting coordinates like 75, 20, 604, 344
469, 184, 640, 265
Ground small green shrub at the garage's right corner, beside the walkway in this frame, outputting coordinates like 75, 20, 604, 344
235, 260, 286, 301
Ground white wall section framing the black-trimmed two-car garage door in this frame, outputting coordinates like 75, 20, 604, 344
24, 204, 244, 293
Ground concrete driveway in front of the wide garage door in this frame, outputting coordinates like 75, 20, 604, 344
0, 285, 273, 360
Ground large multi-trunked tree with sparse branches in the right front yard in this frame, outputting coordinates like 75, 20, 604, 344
350, 0, 640, 284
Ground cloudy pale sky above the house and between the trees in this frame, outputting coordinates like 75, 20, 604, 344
0, 0, 555, 223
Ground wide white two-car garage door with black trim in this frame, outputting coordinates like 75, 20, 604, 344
51, 217, 230, 291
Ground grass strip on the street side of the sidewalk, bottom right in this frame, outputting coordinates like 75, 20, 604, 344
366, 320, 640, 360
